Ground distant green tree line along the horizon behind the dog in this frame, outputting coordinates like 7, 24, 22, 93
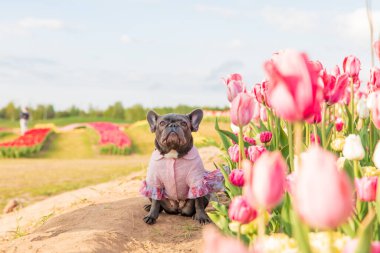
0, 102, 227, 122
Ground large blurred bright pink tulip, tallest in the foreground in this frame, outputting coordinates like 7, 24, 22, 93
264, 50, 323, 122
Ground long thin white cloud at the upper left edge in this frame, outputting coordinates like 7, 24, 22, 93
0, 17, 66, 36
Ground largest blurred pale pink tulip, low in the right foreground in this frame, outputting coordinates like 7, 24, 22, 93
293, 145, 354, 229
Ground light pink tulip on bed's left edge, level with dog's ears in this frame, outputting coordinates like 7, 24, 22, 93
230, 93, 255, 127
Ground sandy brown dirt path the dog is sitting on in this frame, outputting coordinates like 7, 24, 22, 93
0, 147, 224, 253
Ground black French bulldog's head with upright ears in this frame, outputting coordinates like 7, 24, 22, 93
147, 109, 203, 157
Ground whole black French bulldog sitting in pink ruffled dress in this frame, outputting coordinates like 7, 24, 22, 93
140, 109, 223, 225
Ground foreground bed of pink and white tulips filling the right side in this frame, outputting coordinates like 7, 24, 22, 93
204, 50, 380, 253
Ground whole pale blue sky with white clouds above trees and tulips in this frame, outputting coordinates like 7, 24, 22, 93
0, 0, 380, 109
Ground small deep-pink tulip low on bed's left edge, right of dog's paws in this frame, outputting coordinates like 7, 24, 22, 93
228, 196, 257, 224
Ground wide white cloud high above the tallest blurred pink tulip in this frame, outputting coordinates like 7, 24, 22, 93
260, 7, 319, 31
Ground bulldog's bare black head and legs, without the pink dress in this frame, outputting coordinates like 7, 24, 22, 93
144, 109, 210, 224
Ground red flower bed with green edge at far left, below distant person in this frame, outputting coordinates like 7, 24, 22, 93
0, 128, 52, 158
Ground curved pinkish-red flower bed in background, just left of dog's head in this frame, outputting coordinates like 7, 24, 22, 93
88, 122, 132, 155
